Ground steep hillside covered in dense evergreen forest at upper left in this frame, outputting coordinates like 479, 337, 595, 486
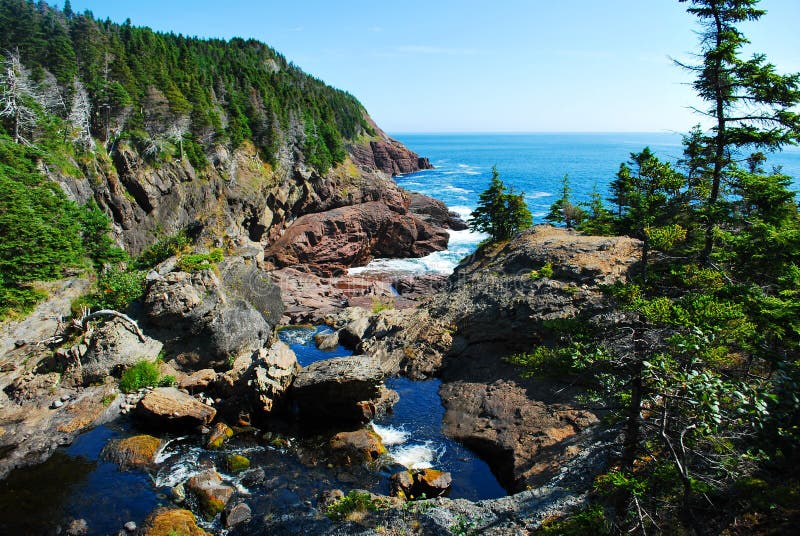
0, 0, 371, 172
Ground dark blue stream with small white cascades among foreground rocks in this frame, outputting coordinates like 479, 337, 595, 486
0, 327, 506, 535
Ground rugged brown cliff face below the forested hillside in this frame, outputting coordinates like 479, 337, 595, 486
53, 125, 447, 272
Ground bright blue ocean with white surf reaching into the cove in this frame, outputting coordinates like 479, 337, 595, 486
350, 133, 800, 274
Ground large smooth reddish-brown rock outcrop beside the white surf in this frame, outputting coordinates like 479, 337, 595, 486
264, 202, 449, 275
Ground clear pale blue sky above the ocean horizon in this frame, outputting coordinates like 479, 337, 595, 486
65, 0, 800, 133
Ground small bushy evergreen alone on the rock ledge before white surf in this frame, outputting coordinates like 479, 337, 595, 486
469, 166, 533, 242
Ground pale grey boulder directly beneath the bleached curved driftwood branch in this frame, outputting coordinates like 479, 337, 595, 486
80, 319, 163, 385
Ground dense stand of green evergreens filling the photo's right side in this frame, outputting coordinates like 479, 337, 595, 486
508, 0, 800, 534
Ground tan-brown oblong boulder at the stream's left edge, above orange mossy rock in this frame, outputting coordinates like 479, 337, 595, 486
136, 387, 217, 429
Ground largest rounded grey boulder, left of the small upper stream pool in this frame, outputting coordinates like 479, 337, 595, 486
144, 261, 283, 370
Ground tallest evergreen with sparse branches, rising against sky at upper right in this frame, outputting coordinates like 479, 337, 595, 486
680, 0, 800, 261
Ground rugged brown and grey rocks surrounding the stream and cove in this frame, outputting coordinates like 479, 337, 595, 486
0, 118, 639, 535
